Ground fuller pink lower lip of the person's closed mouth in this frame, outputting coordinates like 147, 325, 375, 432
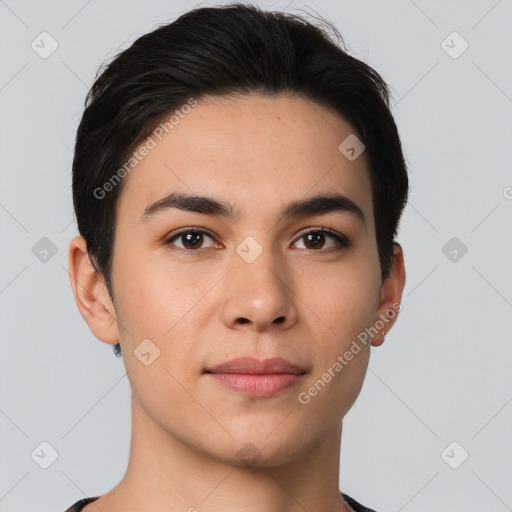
208, 373, 304, 398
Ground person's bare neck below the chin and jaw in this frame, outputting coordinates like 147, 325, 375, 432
91, 397, 352, 512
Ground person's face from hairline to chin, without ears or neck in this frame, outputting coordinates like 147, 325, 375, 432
86, 95, 402, 465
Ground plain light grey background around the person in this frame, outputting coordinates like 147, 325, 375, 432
0, 0, 512, 512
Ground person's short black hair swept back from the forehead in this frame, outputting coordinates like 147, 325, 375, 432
73, 3, 409, 357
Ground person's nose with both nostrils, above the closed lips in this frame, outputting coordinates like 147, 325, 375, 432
222, 244, 297, 333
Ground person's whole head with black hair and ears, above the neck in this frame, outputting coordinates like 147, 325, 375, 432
70, 4, 408, 463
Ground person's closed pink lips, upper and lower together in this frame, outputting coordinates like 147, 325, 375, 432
205, 357, 306, 398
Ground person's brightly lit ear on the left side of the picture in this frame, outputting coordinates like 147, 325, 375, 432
68, 236, 119, 345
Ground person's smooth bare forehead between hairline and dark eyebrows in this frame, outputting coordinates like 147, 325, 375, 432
117, 94, 372, 226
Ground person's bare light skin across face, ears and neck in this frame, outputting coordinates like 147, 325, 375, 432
69, 94, 405, 512
